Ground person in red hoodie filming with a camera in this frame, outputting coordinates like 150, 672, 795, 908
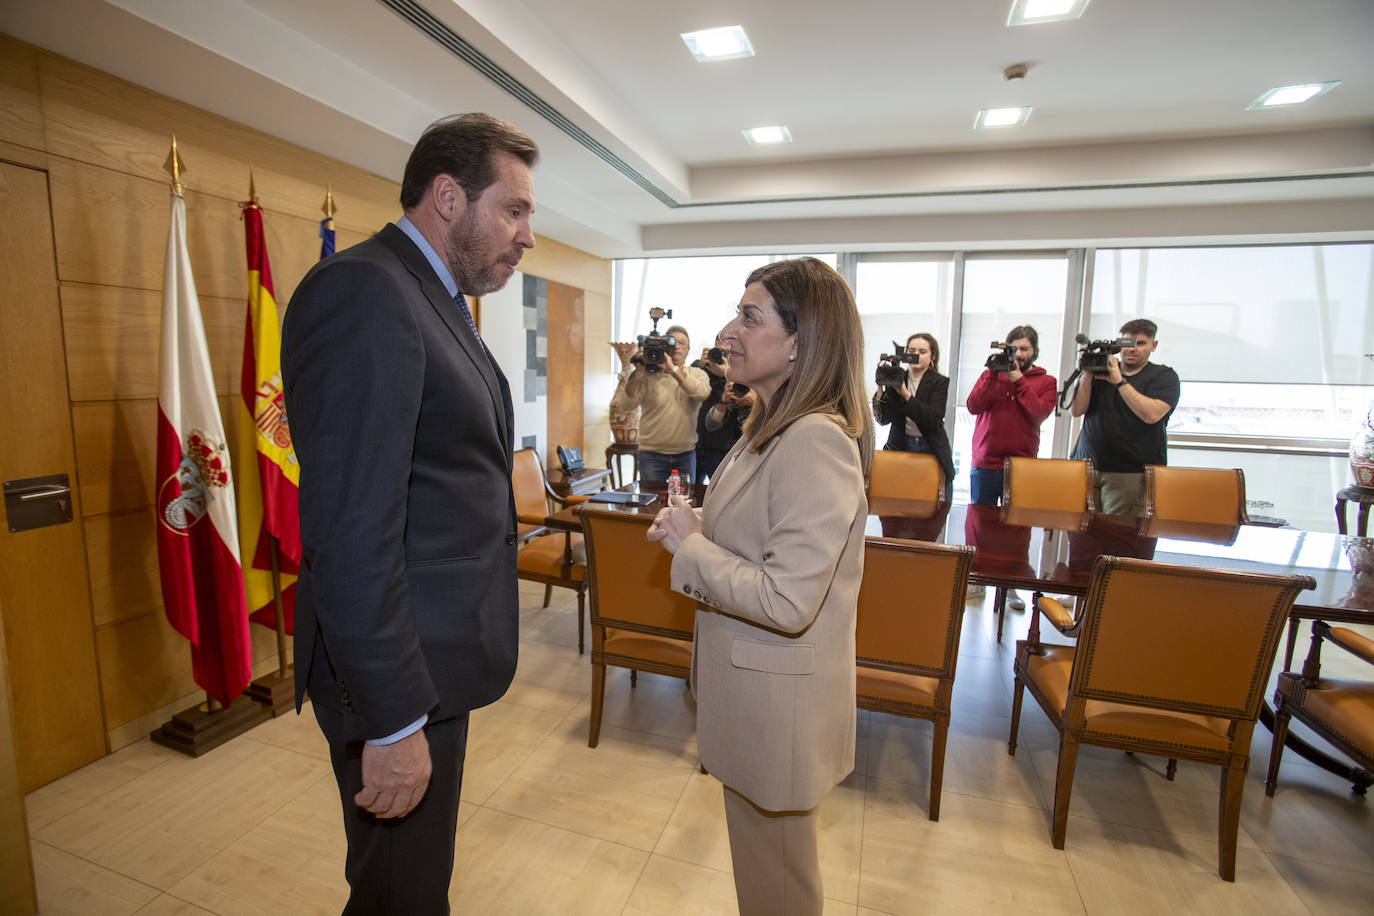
969, 324, 1055, 610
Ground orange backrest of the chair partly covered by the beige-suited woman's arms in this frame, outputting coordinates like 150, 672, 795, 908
577, 507, 697, 640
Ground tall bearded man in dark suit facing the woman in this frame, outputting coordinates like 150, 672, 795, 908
282, 114, 539, 913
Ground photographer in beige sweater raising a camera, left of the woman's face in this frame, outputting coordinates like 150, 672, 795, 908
611, 322, 710, 483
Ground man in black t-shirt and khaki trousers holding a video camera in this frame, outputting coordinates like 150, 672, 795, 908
1070, 319, 1179, 515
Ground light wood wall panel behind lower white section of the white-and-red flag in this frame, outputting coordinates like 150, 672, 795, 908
62, 283, 247, 401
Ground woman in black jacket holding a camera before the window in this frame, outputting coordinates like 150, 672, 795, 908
872, 331, 954, 500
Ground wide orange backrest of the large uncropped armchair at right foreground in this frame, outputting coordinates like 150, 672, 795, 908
1066, 556, 1316, 725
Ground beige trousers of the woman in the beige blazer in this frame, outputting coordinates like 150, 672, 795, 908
725, 786, 826, 916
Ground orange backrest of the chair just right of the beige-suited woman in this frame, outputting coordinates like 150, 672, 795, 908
855, 537, 973, 678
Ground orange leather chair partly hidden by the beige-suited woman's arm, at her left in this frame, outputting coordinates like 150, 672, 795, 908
577, 508, 697, 747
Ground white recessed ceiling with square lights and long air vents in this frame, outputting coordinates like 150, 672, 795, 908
0, 0, 1374, 257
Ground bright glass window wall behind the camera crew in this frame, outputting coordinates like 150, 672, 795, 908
614, 243, 1374, 531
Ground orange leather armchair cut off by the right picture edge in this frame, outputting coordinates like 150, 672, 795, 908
1264, 621, 1374, 795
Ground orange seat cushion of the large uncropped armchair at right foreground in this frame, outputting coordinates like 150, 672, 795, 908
1026, 645, 1230, 751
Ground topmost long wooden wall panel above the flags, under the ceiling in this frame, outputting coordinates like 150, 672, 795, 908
38, 52, 400, 232
